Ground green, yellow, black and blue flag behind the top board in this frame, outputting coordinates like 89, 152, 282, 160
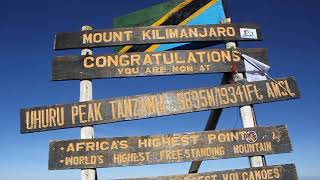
113, 0, 226, 53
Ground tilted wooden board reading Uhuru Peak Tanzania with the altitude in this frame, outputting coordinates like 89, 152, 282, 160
20, 78, 300, 133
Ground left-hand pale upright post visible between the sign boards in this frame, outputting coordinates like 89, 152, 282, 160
79, 26, 97, 180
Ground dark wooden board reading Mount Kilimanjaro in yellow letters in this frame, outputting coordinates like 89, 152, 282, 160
54, 24, 262, 50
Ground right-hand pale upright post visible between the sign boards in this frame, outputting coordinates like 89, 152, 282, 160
221, 18, 265, 167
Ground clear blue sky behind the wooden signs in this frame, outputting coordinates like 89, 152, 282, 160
0, 0, 320, 180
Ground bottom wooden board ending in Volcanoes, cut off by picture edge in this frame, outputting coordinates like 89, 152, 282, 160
122, 164, 298, 180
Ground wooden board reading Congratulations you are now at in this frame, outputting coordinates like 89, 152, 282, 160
52, 48, 267, 80
